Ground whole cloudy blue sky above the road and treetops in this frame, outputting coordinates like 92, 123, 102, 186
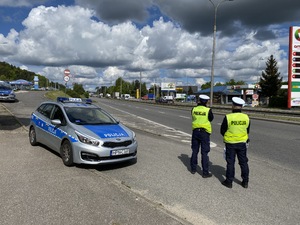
0, 0, 300, 90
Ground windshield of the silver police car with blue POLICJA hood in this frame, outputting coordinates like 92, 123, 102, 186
65, 107, 117, 125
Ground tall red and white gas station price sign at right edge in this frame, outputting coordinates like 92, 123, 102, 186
288, 27, 300, 108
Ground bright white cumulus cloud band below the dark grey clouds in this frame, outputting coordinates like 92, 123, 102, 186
0, 3, 287, 88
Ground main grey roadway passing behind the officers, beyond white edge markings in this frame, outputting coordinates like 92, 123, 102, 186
94, 98, 300, 171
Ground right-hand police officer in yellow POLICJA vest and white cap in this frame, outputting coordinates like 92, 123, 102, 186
220, 97, 250, 188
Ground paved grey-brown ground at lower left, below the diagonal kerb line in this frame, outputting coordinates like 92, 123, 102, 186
0, 103, 189, 225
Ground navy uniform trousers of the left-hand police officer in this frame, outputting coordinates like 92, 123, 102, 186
191, 129, 210, 175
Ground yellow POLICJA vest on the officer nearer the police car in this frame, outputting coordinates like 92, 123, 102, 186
192, 106, 212, 134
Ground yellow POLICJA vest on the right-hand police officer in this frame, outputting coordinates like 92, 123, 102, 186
224, 113, 249, 144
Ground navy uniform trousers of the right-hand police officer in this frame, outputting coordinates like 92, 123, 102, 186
225, 143, 249, 183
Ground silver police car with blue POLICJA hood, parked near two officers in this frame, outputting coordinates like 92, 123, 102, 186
29, 97, 138, 166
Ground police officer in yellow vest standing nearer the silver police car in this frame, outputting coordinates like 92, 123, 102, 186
190, 95, 214, 178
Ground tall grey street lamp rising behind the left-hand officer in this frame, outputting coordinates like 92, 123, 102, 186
209, 0, 233, 107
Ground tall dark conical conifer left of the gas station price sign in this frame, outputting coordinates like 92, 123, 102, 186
259, 55, 282, 97
